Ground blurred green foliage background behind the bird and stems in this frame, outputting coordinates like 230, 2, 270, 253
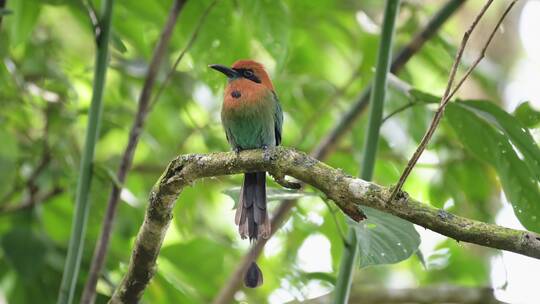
0, 0, 540, 303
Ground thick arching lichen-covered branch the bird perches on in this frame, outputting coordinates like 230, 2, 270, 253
111, 147, 540, 303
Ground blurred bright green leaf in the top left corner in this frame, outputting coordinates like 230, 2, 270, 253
7, 0, 41, 46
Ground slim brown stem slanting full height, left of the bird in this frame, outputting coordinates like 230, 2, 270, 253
81, 0, 186, 304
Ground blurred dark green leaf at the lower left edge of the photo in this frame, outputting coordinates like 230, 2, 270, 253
1, 227, 47, 280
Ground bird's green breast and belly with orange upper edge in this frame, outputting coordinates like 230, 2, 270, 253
221, 95, 276, 150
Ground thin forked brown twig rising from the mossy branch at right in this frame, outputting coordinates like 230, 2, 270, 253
389, 0, 517, 201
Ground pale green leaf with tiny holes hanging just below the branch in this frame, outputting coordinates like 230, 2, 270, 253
355, 207, 420, 268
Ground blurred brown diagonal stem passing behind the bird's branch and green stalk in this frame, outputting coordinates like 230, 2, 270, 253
212, 0, 466, 304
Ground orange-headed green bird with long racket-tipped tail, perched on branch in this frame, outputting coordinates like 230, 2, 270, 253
209, 60, 283, 288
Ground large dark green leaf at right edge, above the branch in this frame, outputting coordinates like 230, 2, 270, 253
445, 102, 540, 232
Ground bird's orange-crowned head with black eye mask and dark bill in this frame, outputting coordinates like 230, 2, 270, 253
209, 60, 274, 91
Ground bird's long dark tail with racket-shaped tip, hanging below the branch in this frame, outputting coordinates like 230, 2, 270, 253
235, 172, 271, 288
